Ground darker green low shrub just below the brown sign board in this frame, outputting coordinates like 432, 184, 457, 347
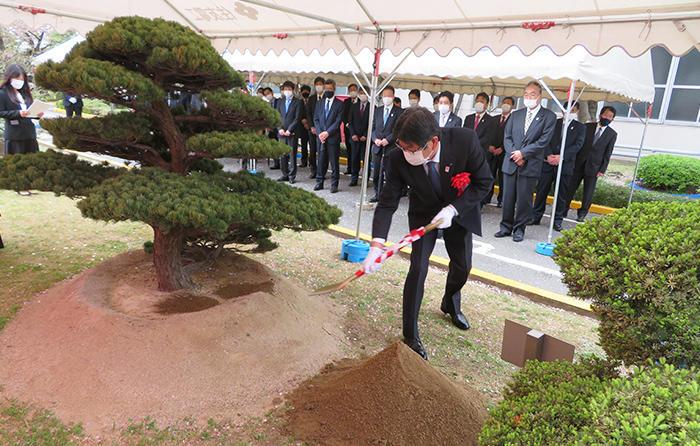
479, 359, 614, 446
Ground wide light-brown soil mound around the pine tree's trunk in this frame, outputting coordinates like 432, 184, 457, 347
0, 252, 343, 434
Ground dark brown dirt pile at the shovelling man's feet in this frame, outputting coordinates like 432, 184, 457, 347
287, 343, 487, 445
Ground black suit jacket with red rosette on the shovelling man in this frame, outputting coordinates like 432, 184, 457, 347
372, 128, 493, 239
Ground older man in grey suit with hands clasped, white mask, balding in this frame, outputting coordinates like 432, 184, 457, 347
494, 81, 557, 242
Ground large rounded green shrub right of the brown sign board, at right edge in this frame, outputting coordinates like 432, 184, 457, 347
554, 202, 700, 365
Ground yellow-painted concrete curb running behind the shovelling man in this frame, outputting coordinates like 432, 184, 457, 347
327, 225, 596, 318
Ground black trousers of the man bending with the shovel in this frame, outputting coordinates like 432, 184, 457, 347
403, 223, 472, 341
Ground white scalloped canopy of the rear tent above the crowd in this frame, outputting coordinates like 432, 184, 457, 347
224, 46, 654, 102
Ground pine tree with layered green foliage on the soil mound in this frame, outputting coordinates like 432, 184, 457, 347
0, 17, 340, 291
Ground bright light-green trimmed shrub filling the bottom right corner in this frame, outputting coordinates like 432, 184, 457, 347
577, 364, 700, 446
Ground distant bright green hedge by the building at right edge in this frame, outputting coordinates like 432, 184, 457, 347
639, 155, 700, 194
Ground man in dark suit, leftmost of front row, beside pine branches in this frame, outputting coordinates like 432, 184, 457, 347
277, 81, 302, 184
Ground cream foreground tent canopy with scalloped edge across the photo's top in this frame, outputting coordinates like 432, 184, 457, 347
0, 0, 700, 56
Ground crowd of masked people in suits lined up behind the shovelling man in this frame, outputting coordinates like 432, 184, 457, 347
258, 77, 617, 242
